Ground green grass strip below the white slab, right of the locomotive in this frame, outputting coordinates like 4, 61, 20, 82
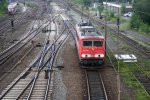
119, 61, 150, 100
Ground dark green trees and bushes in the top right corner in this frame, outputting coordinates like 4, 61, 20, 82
130, 0, 150, 36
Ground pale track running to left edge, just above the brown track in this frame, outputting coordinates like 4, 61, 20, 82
0, 9, 55, 65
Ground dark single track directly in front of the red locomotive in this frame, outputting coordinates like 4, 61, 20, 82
84, 70, 108, 100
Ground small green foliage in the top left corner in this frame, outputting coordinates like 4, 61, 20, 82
0, 0, 8, 16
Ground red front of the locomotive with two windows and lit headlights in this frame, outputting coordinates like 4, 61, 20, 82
80, 37, 105, 65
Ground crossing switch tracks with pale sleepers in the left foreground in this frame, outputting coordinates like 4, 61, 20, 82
0, 8, 71, 100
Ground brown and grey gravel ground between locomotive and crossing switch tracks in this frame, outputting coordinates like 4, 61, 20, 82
53, 34, 82, 100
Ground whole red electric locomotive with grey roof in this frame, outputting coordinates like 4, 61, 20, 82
75, 22, 106, 65
